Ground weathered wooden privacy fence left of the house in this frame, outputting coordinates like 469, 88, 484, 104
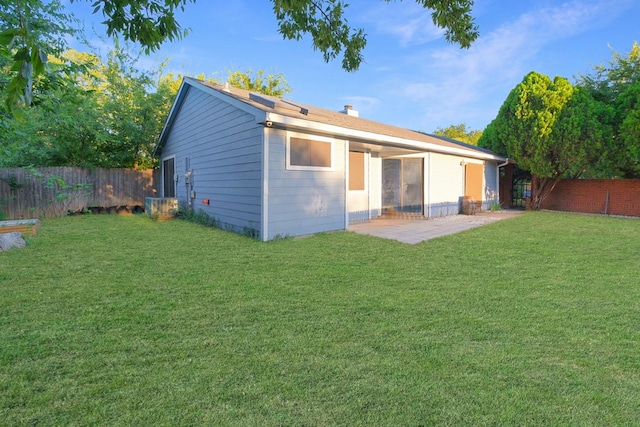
0, 167, 160, 219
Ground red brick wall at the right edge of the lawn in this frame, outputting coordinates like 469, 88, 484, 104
542, 179, 640, 216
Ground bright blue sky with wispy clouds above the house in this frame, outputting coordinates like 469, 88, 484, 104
66, 0, 640, 132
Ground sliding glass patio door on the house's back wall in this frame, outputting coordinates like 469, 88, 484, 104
382, 158, 424, 214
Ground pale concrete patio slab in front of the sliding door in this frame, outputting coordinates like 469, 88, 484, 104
348, 210, 523, 244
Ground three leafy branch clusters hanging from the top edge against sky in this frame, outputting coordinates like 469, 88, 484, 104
76, 0, 478, 71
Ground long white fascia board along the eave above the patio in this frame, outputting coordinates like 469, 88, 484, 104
266, 112, 506, 162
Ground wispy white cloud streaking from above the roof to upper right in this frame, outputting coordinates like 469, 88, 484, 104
388, 0, 629, 126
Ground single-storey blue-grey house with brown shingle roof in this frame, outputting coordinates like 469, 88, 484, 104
158, 78, 505, 241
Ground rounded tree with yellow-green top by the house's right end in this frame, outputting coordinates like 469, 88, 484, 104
479, 72, 610, 209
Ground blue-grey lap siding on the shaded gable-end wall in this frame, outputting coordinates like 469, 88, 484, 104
162, 88, 263, 236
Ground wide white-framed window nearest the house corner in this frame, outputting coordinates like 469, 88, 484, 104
287, 135, 333, 170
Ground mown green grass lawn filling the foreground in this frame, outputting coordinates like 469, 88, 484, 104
0, 213, 640, 426
